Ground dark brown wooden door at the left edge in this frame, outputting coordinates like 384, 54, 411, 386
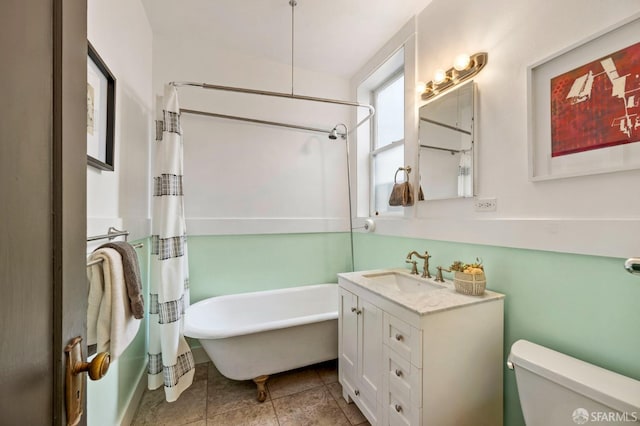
0, 0, 87, 425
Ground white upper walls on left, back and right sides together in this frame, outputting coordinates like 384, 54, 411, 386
87, 0, 640, 257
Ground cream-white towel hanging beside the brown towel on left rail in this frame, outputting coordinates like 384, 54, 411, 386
87, 248, 140, 361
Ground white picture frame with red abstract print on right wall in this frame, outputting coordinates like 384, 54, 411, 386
527, 15, 640, 181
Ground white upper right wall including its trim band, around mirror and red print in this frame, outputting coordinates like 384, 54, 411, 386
352, 0, 640, 257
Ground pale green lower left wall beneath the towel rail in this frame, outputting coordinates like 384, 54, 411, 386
87, 239, 149, 426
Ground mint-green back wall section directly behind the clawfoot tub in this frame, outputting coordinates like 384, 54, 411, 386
188, 233, 351, 303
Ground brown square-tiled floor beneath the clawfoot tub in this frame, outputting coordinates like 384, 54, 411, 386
132, 361, 369, 426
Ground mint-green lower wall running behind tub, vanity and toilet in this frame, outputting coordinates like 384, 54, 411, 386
176, 233, 640, 426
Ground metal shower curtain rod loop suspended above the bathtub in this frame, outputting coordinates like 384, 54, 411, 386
169, 81, 376, 133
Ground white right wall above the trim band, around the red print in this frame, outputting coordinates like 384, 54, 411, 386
418, 0, 640, 218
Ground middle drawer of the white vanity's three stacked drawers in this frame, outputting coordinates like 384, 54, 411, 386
382, 346, 422, 407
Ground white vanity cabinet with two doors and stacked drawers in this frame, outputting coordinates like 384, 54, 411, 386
338, 271, 504, 426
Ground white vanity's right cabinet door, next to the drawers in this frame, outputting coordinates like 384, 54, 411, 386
358, 298, 382, 424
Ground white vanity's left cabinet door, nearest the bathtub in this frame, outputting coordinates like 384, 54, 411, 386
338, 288, 358, 400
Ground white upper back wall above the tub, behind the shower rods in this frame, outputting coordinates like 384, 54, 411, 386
153, 34, 352, 235
